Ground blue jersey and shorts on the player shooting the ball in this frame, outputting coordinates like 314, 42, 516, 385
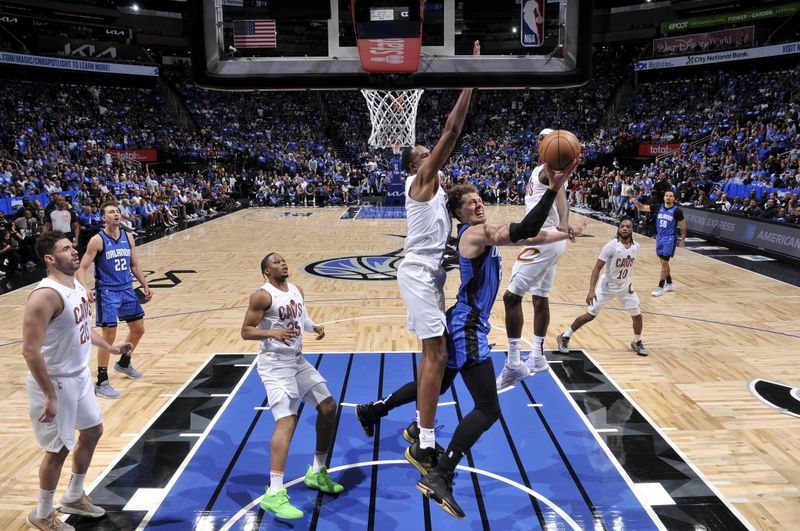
447, 224, 502, 370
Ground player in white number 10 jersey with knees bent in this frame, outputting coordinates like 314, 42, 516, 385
556, 216, 647, 356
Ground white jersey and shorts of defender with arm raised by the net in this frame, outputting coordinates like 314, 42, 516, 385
397, 175, 452, 339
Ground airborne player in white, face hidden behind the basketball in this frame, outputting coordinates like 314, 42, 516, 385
496, 129, 574, 389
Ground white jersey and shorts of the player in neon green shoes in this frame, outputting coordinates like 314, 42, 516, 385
257, 282, 331, 420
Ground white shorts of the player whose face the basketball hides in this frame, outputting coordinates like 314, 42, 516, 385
506, 238, 567, 297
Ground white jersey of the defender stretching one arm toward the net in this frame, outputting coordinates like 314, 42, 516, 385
403, 175, 452, 264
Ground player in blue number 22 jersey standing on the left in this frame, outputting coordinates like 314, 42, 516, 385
76, 201, 152, 398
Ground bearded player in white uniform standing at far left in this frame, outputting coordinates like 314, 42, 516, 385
22, 231, 133, 530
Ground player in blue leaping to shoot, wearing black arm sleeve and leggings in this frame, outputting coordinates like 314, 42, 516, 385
356, 161, 578, 518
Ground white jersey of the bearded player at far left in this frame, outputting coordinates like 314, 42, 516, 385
34, 278, 92, 376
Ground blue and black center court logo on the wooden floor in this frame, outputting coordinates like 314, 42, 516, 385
303, 246, 458, 280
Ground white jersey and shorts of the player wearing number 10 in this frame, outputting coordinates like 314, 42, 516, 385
587, 238, 642, 317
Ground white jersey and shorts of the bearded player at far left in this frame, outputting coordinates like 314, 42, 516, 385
26, 278, 103, 452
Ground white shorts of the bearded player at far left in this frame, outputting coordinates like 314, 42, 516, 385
26, 368, 103, 453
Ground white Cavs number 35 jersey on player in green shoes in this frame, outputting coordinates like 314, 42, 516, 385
258, 282, 306, 354
